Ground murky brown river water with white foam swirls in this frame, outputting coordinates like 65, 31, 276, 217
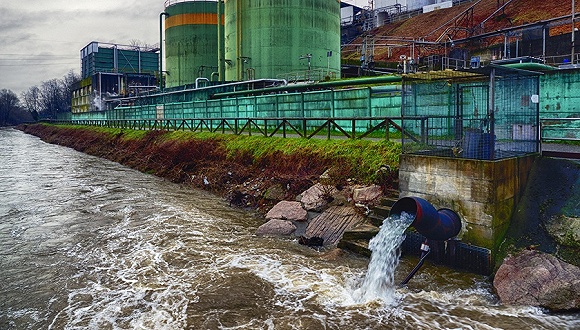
0, 129, 580, 329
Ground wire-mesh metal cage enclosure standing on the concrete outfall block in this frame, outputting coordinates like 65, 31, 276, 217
401, 65, 541, 160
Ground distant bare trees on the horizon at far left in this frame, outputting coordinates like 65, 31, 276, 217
0, 70, 80, 126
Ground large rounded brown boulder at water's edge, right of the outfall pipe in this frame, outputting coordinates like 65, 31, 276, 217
493, 250, 580, 311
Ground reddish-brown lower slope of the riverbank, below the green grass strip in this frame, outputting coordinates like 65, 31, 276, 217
18, 125, 397, 213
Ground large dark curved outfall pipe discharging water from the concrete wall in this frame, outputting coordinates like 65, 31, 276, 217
389, 197, 461, 241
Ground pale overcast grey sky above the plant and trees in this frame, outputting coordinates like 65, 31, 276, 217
0, 0, 368, 97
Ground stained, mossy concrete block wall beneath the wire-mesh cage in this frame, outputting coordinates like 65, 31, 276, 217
399, 154, 537, 253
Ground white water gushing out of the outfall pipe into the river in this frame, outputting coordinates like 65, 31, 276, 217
354, 212, 415, 305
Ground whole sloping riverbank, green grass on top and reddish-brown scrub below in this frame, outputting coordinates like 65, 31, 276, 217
19, 124, 401, 208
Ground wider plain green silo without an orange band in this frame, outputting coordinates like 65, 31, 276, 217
224, 0, 340, 81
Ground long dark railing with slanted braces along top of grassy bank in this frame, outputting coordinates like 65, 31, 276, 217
51, 117, 426, 140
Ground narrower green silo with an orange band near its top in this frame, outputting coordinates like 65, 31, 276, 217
165, 0, 223, 87
